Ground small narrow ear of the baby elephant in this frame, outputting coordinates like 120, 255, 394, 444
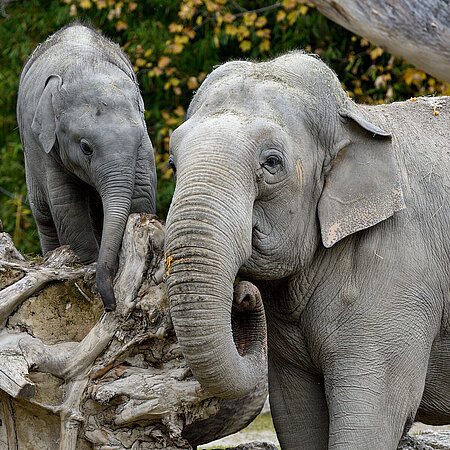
31, 75, 62, 153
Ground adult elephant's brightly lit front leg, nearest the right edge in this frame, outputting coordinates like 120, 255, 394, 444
325, 337, 428, 450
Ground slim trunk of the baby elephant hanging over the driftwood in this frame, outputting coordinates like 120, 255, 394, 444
96, 161, 135, 311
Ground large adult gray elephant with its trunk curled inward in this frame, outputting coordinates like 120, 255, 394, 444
166, 52, 450, 450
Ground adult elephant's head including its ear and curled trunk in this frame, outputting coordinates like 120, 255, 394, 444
166, 52, 403, 397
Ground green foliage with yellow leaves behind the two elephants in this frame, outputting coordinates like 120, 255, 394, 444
0, 0, 449, 252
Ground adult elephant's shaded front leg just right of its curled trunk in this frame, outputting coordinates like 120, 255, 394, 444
269, 355, 328, 450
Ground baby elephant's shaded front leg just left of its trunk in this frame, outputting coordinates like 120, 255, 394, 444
49, 177, 98, 264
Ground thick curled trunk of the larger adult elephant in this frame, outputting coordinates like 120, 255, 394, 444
165, 192, 266, 398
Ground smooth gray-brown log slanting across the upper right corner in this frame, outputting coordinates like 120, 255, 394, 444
312, 0, 450, 81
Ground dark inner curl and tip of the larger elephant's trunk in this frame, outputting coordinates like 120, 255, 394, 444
231, 281, 265, 356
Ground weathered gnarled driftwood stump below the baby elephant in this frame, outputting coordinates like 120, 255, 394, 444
0, 214, 267, 450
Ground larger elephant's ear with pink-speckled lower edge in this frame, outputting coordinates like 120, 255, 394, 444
318, 111, 405, 248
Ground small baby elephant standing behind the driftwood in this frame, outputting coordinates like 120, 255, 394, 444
17, 24, 156, 311
